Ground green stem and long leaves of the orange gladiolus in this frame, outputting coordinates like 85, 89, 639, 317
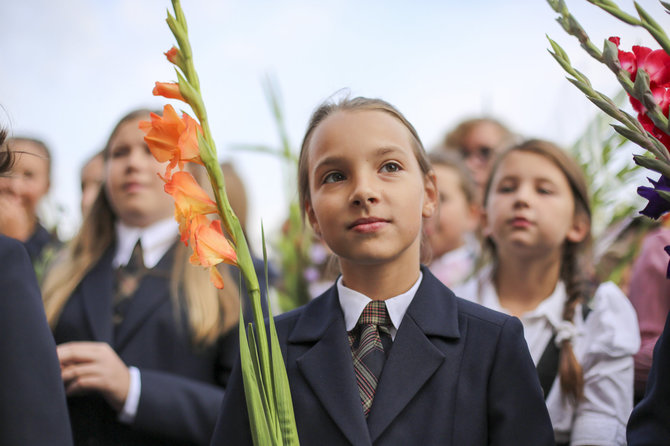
167, 0, 298, 445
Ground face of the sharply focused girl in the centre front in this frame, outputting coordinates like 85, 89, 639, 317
306, 110, 436, 267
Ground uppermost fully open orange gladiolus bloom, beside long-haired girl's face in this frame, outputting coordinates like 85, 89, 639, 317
140, 104, 202, 178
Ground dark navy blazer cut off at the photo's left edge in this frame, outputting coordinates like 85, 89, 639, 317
0, 236, 72, 446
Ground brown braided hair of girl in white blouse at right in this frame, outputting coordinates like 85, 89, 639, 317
484, 139, 594, 402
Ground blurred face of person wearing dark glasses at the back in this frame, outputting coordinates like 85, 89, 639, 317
460, 122, 504, 190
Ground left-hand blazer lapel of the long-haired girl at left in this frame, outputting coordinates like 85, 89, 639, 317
80, 248, 114, 344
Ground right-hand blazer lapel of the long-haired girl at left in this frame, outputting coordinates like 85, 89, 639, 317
114, 245, 176, 351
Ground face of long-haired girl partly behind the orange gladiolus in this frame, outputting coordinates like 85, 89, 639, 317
105, 118, 174, 227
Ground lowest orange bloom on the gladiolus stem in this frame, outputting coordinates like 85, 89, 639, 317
189, 216, 237, 289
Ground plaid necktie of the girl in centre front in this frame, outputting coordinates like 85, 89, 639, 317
349, 300, 391, 418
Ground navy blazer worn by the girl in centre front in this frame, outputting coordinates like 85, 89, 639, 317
212, 268, 554, 446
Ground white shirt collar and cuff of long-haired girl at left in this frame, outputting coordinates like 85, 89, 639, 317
112, 217, 179, 424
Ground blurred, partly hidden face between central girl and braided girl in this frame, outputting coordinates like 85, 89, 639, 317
426, 165, 479, 258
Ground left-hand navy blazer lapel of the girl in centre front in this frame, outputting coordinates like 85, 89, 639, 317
289, 287, 371, 445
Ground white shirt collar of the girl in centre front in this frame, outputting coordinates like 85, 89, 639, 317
336, 271, 423, 339
